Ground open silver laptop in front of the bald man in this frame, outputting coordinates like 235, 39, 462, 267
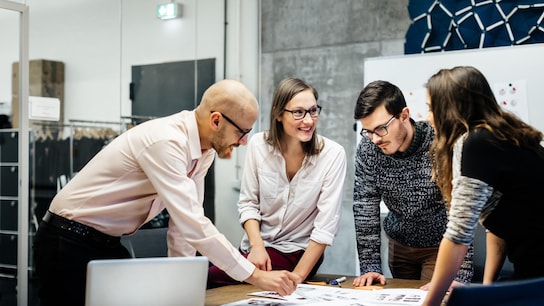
85, 256, 208, 306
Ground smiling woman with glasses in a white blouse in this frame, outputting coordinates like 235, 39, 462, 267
208, 78, 346, 288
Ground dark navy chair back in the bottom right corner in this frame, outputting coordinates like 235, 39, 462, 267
446, 277, 544, 306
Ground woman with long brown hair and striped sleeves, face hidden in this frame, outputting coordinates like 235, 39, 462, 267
424, 66, 544, 305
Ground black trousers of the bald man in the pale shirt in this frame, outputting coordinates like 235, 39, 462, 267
33, 216, 131, 306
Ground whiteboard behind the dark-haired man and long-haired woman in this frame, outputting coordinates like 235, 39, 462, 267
364, 44, 544, 132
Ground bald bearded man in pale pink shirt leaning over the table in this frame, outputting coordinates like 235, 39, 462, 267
34, 80, 296, 305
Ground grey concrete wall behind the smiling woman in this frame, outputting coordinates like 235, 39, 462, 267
260, 0, 410, 275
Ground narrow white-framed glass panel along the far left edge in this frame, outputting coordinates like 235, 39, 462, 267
0, 0, 30, 305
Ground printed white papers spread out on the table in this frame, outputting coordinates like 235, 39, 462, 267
220, 284, 427, 306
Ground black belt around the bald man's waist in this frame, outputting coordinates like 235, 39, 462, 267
43, 211, 121, 244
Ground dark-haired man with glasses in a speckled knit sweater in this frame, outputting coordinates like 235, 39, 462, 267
353, 81, 473, 289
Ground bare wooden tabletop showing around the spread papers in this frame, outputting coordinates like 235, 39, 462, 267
205, 276, 426, 306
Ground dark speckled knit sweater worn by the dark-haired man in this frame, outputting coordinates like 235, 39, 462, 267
353, 121, 474, 283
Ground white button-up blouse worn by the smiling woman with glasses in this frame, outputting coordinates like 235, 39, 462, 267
238, 132, 346, 253
